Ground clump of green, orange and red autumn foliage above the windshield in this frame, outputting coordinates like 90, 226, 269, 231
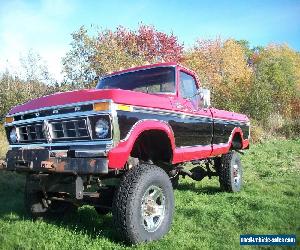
63, 25, 183, 88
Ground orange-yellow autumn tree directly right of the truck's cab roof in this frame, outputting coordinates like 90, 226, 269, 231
183, 39, 253, 111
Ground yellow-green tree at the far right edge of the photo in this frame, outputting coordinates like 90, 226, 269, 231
248, 45, 299, 123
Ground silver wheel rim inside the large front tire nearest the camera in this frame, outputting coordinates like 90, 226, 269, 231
141, 185, 166, 232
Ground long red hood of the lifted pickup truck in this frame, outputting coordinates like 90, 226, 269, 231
9, 89, 172, 115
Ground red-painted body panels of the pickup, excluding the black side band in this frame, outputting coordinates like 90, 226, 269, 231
9, 63, 249, 169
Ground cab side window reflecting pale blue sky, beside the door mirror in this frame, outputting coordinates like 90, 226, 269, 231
179, 72, 199, 109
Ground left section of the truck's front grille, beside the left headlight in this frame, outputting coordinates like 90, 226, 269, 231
18, 123, 46, 142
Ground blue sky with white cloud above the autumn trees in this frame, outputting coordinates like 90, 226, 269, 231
0, 0, 300, 80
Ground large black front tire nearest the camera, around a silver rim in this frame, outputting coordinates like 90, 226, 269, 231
112, 164, 174, 244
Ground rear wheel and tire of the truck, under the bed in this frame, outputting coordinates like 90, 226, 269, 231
217, 151, 243, 192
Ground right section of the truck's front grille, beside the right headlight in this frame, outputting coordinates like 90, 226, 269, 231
49, 118, 90, 140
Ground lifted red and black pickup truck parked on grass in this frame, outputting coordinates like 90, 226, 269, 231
2, 63, 249, 243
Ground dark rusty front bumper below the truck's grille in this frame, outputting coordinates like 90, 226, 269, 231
5, 148, 108, 174
